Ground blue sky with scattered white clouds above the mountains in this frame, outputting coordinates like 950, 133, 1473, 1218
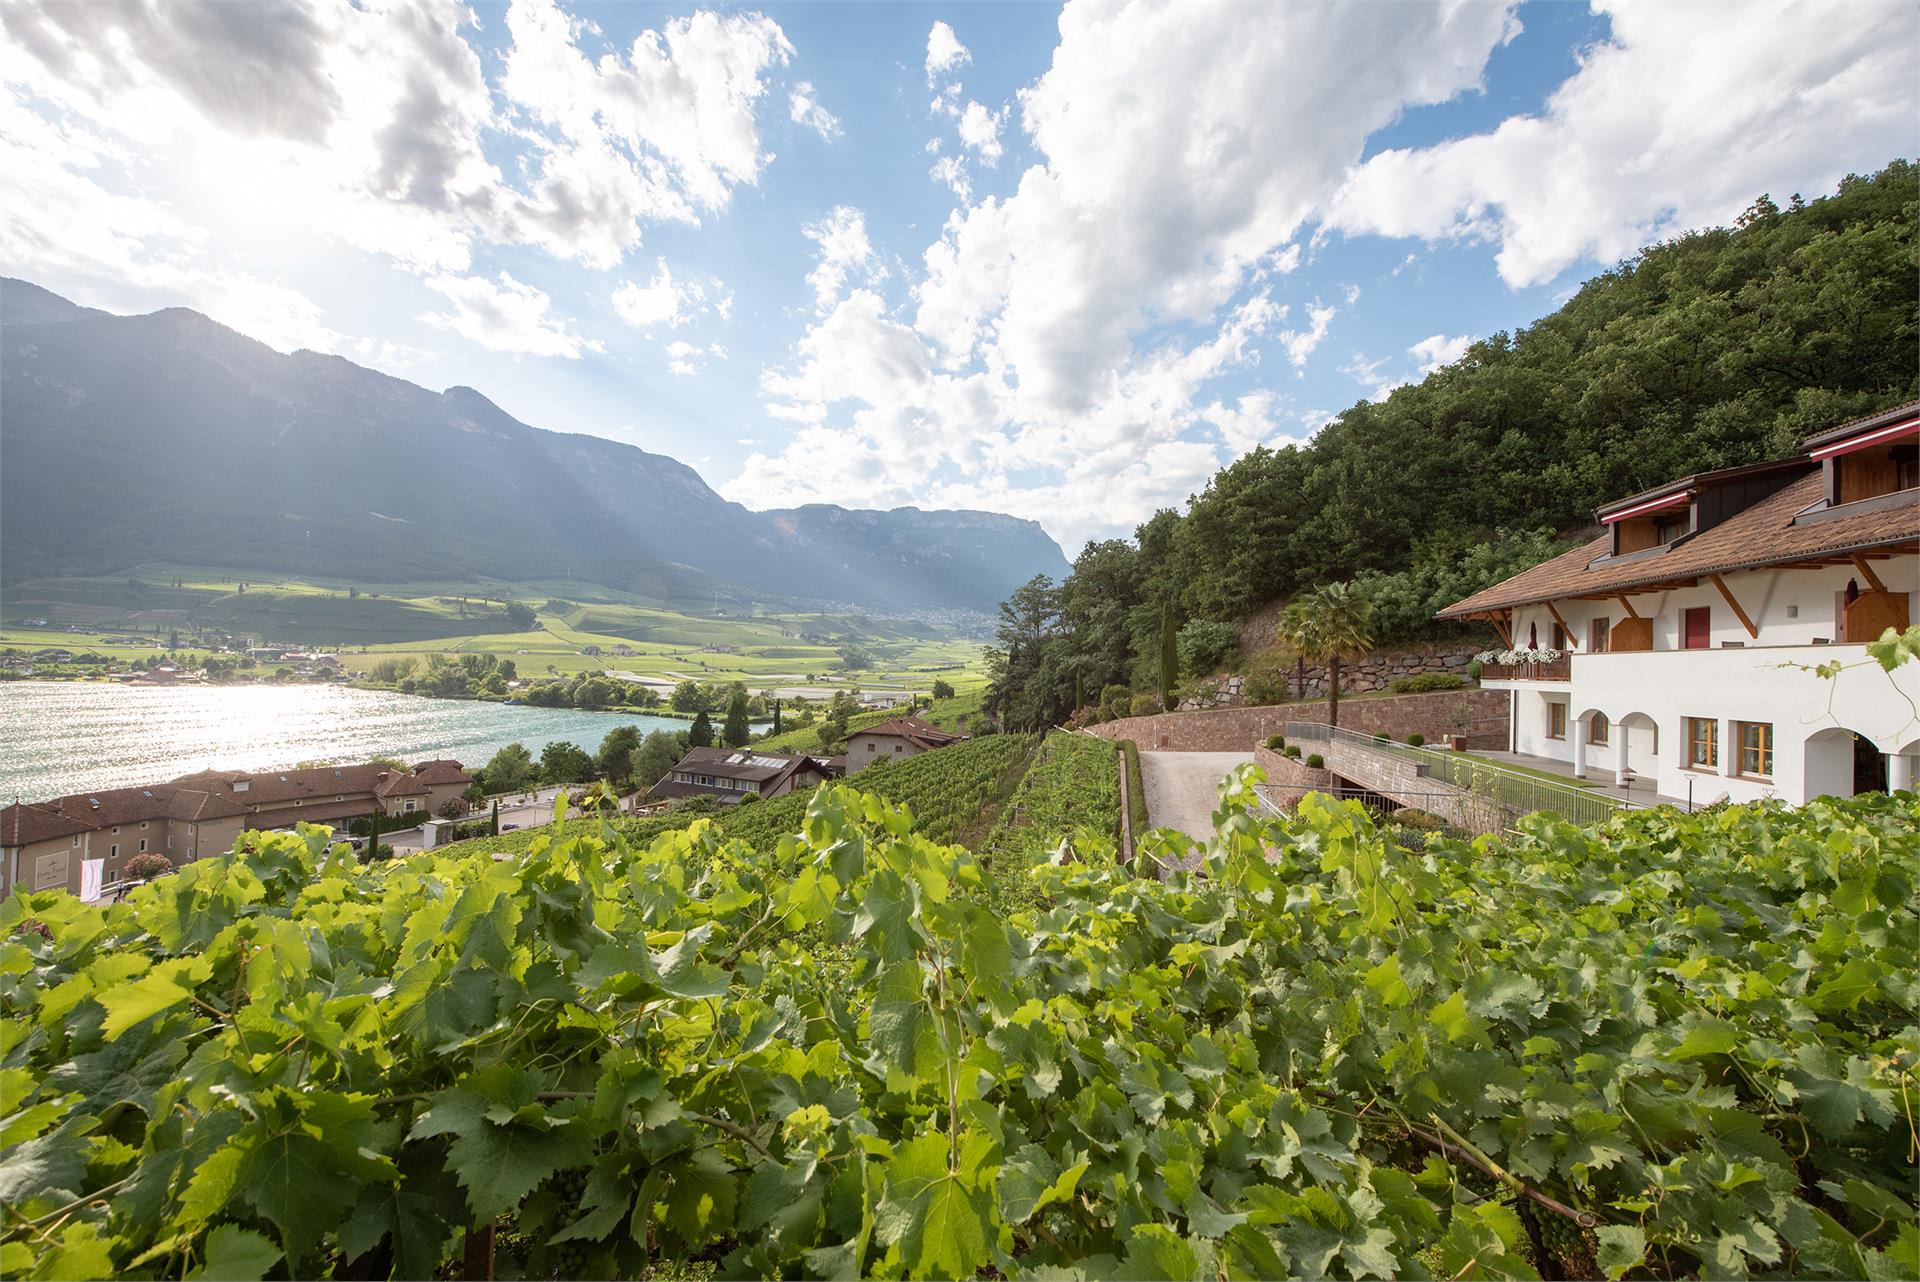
0, 0, 1920, 555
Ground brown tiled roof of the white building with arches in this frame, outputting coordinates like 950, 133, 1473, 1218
1438, 472, 1920, 618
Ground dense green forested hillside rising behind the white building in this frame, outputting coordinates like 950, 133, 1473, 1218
995, 159, 1920, 725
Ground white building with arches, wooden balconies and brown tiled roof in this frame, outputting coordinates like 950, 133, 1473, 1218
1440, 401, 1920, 804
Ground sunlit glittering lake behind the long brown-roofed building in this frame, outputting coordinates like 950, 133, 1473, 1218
0, 681, 706, 806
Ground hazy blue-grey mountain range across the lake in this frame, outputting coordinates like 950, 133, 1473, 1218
0, 280, 1068, 608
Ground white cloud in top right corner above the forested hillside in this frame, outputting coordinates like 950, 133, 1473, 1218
1331, 0, 1920, 286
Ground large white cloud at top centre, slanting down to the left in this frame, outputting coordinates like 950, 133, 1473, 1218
916, 0, 1513, 411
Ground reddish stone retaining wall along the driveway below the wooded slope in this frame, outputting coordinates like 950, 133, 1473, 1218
1087, 687, 1507, 752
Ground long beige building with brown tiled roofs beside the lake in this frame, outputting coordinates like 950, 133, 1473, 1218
0, 760, 470, 896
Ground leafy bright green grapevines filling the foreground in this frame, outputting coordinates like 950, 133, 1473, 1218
0, 771, 1920, 1278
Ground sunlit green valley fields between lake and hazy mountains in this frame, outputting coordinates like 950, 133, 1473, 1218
0, 566, 985, 695
